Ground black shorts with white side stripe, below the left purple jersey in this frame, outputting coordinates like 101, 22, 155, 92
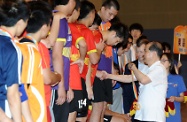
52, 90, 69, 122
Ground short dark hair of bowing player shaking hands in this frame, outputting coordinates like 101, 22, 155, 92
109, 22, 128, 40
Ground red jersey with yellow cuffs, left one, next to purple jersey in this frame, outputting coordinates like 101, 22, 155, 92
69, 23, 84, 90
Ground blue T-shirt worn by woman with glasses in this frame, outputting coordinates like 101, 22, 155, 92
166, 74, 186, 122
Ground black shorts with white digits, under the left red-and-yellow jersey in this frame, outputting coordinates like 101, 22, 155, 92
69, 90, 84, 113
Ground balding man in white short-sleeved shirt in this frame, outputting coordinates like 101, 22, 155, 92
129, 42, 167, 122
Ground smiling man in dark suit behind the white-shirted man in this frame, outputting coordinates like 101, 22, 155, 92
122, 36, 149, 122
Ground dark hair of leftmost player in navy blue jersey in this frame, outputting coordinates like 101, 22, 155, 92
0, 1, 29, 27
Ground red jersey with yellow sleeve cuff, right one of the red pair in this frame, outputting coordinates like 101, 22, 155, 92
76, 24, 97, 79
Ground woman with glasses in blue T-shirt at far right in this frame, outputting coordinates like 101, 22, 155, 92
161, 53, 186, 122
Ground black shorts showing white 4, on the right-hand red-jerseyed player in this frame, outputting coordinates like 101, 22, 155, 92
77, 78, 90, 117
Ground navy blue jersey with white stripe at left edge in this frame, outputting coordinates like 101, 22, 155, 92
0, 29, 22, 116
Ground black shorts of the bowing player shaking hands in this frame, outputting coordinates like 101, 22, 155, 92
92, 77, 113, 104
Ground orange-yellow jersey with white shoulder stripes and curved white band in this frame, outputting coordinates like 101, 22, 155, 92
18, 37, 47, 122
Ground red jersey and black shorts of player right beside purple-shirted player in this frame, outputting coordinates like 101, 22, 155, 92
69, 23, 84, 113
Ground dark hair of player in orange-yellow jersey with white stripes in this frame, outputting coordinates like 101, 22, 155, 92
26, 1, 52, 33
